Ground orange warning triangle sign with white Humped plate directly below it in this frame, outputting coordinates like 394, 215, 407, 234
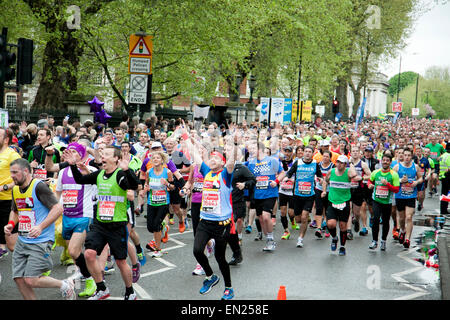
128, 34, 153, 74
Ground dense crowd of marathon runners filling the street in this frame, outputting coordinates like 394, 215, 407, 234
0, 114, 450, 300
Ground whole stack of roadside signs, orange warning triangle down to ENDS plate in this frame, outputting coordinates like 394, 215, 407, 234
128, 33, 153, 113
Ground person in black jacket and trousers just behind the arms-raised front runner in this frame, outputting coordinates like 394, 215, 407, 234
228, 145, 256, 265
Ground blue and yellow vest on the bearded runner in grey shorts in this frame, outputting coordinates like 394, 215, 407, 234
13, 179, 55, 243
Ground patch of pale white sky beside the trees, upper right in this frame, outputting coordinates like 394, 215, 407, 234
380, 0, 450, 79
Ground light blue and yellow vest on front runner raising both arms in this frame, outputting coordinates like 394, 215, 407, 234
200, 171, 233, 221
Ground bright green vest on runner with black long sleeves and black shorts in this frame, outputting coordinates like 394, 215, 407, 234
97, 169, 128, 222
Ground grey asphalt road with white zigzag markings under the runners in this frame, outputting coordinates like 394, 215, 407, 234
0, 194, 441, 300
